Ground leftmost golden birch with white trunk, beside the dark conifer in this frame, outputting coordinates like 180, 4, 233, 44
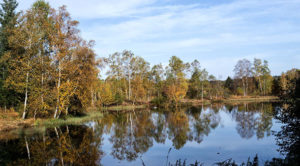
4, 1, 50, 119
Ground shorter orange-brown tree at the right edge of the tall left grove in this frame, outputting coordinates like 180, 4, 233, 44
66, 40, 98, 113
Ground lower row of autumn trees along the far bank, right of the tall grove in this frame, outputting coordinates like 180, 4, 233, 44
95, 50, 300, 106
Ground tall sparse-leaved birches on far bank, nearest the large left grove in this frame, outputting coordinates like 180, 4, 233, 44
104, 50, 150, 103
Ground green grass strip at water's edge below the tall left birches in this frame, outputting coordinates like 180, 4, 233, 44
34, 112, 102, 127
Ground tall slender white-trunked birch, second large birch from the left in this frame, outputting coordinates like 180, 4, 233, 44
51, 6, 79, 118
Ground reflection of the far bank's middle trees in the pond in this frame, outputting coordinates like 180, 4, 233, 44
99, 108, 220, 161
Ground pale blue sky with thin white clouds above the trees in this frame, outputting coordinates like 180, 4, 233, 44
18, 0, 300, 79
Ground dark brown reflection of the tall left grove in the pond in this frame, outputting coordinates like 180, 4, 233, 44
0, 126, 102, 165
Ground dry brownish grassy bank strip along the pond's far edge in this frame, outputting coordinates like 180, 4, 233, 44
0, 96, 279, 134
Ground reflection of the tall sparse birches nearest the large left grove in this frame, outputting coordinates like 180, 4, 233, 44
109, 112, 154, 161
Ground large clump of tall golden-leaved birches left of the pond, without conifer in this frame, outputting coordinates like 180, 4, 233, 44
1, 0, 98, 119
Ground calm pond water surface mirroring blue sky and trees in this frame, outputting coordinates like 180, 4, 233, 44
0, 103, 298, 166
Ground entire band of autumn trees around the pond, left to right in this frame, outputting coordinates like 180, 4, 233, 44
0, 0, 300, 119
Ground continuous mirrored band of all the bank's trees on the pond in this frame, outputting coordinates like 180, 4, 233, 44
0, 103, 288, 165
